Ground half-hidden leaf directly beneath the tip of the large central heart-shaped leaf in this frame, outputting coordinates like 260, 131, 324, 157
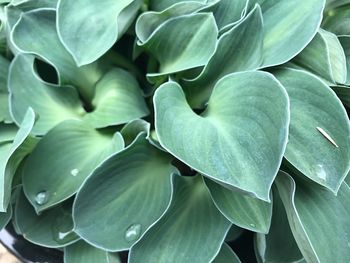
205, 180, 272, 233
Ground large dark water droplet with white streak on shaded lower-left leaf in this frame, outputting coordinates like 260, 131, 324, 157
52, 214, 77, 244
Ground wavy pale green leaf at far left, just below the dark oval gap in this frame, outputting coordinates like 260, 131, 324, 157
9, 54, 85, 135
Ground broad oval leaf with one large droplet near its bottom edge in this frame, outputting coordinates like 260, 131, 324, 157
74, 133, 176, 253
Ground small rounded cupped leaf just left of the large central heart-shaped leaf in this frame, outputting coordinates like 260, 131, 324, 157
84, 68, 149, 128
